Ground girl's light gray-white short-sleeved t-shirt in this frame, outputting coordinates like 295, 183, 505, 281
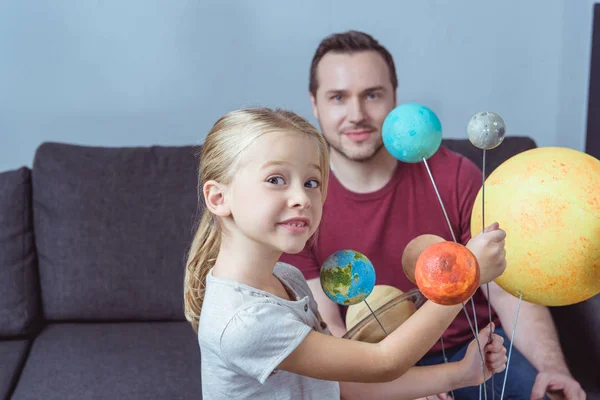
198, 263, 340, 400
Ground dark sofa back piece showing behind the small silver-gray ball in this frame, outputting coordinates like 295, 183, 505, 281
442, 136, 537, 176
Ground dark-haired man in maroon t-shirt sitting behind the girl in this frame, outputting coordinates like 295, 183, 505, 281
282, 31, 585, 399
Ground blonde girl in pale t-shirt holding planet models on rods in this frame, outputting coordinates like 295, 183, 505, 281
184, 108, 506, 400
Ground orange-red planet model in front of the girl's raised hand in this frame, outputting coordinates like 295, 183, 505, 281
415, 241, 480, 305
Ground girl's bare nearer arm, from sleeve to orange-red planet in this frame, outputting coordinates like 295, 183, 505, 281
279, 301, 462, 383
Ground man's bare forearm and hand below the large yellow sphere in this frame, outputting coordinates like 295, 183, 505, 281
483, 282, 585, 399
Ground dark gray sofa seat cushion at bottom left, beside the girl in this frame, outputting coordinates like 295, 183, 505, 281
12, 322, 202, 400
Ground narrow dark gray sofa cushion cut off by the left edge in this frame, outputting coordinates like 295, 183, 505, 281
0, 167, 41, 337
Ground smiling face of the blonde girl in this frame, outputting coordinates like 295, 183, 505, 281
225, 132, 323, 253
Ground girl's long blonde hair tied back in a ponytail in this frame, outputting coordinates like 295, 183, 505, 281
183, 107, 329, 333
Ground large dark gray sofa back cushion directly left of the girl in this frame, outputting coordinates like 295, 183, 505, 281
33, 143, 198, 321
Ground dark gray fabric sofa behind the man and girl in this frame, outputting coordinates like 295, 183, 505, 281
0, 137, 600, 400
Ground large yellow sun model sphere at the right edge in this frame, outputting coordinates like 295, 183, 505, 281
471, 147, 600, 306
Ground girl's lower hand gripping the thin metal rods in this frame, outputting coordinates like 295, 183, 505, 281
459, 324, 508, 386
